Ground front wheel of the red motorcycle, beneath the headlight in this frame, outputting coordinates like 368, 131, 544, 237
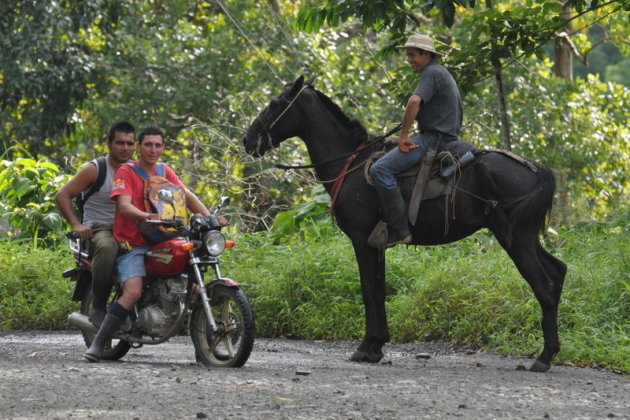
190, 286, 256, 367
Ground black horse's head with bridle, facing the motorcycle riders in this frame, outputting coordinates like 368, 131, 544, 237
243, 76, 312, 157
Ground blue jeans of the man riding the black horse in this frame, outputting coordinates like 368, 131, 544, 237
370, 134, 438, 190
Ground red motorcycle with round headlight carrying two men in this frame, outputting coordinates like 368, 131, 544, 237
63, 197, 255, 367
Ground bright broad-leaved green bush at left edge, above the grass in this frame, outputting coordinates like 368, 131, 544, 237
0, 158, 69, 243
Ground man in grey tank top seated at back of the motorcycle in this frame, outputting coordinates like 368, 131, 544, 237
55, 121, 136, 327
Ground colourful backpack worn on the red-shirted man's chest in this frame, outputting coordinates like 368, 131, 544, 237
127, 163, 188, 243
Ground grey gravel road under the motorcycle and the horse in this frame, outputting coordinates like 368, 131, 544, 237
0, 331, 630, 419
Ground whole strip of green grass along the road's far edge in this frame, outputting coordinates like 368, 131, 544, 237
0, 214, 630, 372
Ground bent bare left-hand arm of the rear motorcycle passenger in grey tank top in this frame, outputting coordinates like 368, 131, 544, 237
55, 163, 98, 239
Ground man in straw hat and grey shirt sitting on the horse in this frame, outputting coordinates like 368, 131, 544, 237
370, 35, 462, 247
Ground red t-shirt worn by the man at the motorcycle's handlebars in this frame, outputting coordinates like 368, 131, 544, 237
110, 165, 185, 246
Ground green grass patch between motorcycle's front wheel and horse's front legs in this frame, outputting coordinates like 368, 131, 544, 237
223, 228, 364, 339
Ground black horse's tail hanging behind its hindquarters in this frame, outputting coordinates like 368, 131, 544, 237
509, 165, 556, 233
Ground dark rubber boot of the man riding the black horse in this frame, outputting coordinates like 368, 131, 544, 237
376, 187, 413, 248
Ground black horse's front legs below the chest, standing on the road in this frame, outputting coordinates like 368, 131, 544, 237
350, 239, 389, 363
